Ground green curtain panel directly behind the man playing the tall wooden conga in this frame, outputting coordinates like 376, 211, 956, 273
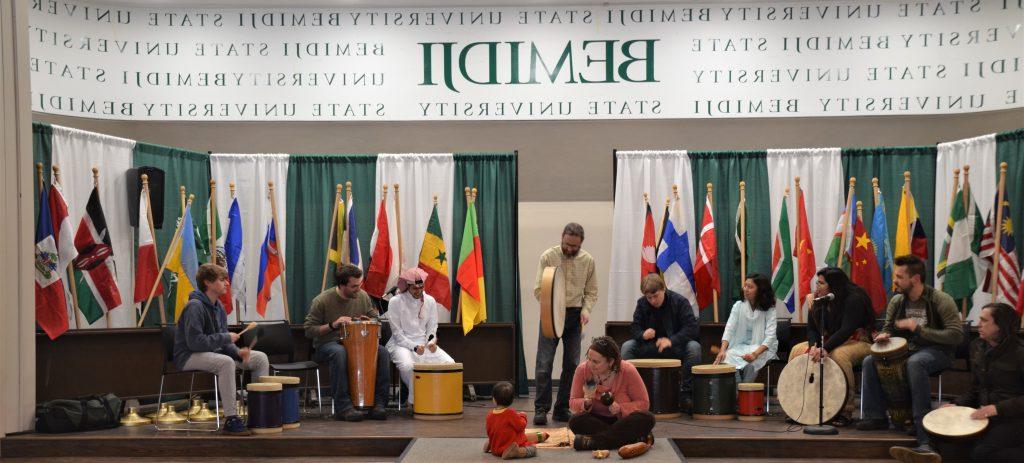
286, 155, 377, 324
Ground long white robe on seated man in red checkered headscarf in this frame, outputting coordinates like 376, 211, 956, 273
386, 291, 455, 404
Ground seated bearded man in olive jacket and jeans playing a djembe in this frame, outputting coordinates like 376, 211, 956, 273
857, 255, 964, 457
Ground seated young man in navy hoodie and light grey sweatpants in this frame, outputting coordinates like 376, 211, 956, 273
174, 263, 270, 435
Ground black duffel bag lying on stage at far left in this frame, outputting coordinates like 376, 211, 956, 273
36, 393, 124, 433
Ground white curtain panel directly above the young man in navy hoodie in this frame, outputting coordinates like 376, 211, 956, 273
207, 154, 288, 323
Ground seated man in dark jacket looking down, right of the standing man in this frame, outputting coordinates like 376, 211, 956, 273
622, 273, 700, 396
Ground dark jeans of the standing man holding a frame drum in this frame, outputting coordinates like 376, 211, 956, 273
534, 307, 583, 415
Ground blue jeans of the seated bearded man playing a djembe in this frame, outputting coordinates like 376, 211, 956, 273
860, 347, 952, 445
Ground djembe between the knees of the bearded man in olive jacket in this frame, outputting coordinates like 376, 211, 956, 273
871, 336, 913, 427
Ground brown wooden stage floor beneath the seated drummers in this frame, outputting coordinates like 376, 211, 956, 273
0, 397, 913, 462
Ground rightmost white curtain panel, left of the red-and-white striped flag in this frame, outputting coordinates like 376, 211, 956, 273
937, 133, 991, 322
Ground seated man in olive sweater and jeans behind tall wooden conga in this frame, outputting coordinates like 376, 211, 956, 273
303, 263, 391, 421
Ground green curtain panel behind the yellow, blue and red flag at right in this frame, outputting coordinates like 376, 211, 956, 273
843, 146, 943, 285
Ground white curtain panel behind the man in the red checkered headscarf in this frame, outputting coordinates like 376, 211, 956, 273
367, 153, 459, 323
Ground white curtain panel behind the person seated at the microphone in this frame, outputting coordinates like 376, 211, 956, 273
767, 148, 848, 321
